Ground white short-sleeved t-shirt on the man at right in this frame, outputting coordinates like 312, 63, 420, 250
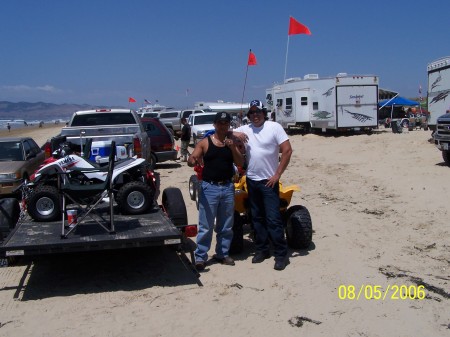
235, 121, 289, 181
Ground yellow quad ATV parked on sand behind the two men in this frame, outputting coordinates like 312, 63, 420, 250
189, 167, 312, 254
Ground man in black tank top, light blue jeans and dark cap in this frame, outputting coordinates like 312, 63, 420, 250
188, 112, 244, 270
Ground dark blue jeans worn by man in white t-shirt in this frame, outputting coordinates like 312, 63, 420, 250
247, 178, 288, 260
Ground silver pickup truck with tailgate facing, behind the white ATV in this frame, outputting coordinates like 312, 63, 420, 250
60, 109, 151, 162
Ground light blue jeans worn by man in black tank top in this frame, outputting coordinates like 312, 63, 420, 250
195, 181, 234, 262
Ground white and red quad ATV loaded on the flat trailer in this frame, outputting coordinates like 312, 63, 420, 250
26, 143, 158, 221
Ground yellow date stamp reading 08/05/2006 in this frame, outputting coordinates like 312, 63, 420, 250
338, 284, 426, 301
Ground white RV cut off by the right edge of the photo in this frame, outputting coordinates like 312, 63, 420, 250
427, 56, 450, 131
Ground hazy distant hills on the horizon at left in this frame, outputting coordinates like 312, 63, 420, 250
0, 101, 121, 120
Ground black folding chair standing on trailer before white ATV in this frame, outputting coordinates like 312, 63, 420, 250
59, 141, 116, 238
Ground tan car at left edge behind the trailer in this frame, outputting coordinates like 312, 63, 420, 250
0, 137, 45, 197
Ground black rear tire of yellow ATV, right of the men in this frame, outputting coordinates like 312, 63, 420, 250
285, 206, 312, 249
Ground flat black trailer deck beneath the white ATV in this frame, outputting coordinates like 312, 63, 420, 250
0, 208, 183, 256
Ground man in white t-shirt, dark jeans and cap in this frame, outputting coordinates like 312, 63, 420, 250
233, 100, 292, 270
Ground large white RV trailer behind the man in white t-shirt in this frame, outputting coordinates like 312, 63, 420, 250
266, 73, 378, 132
